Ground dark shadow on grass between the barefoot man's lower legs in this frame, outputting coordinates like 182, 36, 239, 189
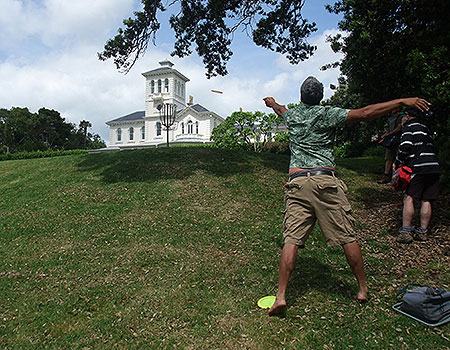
288, 252, 356, 297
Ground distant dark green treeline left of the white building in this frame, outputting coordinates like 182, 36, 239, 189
0, 107, 106, 154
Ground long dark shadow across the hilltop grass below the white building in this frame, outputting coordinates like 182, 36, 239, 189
77, 147, 289, 183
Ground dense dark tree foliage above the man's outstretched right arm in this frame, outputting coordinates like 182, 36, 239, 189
328, 0, 450, 186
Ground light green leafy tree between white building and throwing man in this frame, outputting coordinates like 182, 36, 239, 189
211, 112, 283, 152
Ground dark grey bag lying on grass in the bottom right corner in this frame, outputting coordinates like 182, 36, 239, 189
394, 283, 450, 327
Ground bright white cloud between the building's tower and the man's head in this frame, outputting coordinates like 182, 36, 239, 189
174, 30, 342, 116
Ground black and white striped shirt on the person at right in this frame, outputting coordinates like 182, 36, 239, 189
395, 118, 440, 174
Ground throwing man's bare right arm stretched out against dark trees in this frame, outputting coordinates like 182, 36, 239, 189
346, 97, 430, 124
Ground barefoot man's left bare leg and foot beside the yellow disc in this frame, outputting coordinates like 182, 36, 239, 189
269, 243, 298, 316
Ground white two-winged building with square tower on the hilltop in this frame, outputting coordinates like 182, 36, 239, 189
106, 60, 224, 149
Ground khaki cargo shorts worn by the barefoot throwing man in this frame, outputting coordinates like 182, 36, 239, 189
283, 175, 356, 247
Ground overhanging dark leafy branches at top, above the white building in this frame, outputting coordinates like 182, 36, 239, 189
98, 0, 316, 78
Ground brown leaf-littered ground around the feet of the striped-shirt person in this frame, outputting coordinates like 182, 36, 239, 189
354, 184, 450, 287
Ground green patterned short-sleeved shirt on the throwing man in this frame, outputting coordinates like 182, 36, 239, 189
283, 103, 349, 169
